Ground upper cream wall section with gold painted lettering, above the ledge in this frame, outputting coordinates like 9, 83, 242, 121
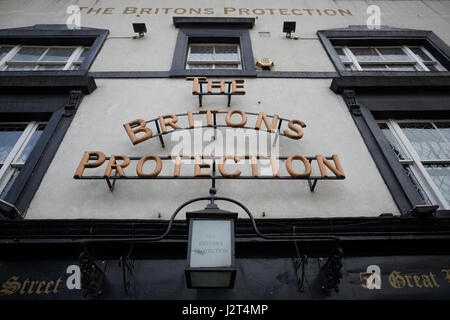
0, 0, 450, 71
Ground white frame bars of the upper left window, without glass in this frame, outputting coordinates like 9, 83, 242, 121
0, 45, 90, 71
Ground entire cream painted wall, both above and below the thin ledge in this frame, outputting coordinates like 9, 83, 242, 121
0, 0, 450, 219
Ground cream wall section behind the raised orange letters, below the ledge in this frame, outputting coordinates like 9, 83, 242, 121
27, 79, 398, 219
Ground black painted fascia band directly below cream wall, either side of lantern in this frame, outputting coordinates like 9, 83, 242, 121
0, 215, 450, 258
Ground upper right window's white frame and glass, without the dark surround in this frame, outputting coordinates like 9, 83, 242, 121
335, 46, 446, 71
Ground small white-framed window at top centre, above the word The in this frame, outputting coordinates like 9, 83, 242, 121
186, 43, 241, 69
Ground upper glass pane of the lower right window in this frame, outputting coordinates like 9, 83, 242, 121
399, 123, 450, 160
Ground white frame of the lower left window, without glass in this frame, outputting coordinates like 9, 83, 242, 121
0, 121, 46, 194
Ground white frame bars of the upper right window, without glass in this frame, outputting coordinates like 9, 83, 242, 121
335, 46, 447, 72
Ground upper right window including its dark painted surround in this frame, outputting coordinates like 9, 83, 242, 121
317, 25, 450, 77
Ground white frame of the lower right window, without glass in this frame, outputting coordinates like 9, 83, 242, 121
377, 119, 450, 209
